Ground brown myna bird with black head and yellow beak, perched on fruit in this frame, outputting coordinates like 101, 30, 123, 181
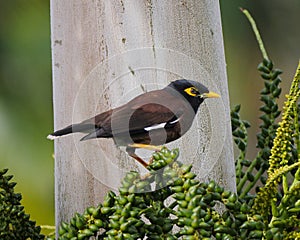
48, 79, 219, 167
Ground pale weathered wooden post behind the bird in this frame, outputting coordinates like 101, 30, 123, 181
51, 0, 235, 228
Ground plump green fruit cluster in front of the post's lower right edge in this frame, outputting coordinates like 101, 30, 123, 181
172, 171, 264, 240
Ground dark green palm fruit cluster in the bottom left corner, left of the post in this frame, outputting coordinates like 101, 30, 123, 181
0, 169, 44, 240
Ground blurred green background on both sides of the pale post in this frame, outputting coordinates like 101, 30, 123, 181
0, 0, 300, 229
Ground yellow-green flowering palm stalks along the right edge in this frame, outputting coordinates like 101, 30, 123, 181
253, 61, 300, 239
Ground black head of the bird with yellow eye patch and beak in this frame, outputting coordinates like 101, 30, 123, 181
168, 79, 220, 112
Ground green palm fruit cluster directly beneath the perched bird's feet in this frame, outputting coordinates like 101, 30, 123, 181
59, 148, 178, 239
